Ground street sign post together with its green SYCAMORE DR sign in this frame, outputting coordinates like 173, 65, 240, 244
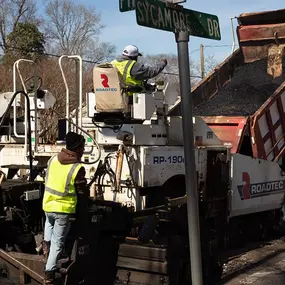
132, 0, 221, 285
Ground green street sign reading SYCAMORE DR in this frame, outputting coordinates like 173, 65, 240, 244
135, 0, 221, 40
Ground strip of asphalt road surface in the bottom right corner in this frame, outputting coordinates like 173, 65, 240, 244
218, 239, 285, 285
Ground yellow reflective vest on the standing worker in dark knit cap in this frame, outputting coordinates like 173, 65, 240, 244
43, 155, 82, 214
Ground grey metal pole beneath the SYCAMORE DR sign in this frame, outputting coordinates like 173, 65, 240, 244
175, 31, 203, 285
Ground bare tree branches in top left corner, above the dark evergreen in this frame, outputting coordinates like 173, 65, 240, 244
0, 0, 39, 53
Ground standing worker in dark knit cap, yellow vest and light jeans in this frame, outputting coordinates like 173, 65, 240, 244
43, 132, 87, 285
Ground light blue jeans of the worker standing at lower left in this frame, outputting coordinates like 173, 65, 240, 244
44, 212, 71, 271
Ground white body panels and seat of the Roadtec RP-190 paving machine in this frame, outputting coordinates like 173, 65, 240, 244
0, 57, 285, 217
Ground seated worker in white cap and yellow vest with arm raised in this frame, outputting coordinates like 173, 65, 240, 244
111, 45, 167, 96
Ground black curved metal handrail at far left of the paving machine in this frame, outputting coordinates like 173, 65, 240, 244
0, 91, 33, 182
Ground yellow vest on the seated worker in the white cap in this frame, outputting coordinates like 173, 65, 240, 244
111, 59, 144, 96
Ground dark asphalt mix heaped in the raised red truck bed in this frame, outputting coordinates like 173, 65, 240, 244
193, 59, 285, 116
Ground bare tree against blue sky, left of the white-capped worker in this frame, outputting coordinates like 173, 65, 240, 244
43, 0, 114, 62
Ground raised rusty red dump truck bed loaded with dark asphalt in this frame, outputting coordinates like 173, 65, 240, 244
170, 10, 285, 161
